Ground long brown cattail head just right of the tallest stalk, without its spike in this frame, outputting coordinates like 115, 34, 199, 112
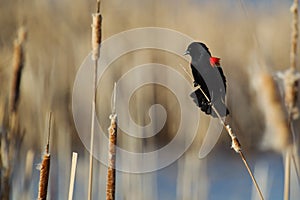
106, 113, 117, 200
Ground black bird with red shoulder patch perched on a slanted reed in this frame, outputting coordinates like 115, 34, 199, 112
185, 42, 229, 117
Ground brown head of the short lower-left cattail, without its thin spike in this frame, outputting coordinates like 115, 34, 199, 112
38, 154, 50, 200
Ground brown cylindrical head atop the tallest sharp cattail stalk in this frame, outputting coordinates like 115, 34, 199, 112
92, 13, 102, 60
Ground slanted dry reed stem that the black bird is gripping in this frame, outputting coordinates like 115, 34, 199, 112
183, 67, 264, 200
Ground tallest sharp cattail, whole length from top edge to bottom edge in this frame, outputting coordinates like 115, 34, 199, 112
87, 0, 102, 200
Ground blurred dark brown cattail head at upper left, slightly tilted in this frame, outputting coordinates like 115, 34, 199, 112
10, 26, 27, 112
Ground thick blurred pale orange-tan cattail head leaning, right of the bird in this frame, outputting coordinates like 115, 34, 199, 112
258, 72, 290, 151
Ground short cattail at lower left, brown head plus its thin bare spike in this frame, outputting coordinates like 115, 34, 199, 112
38, 112, 52, 200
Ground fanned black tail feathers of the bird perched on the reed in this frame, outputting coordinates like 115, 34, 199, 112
190, 89, 229, 118
